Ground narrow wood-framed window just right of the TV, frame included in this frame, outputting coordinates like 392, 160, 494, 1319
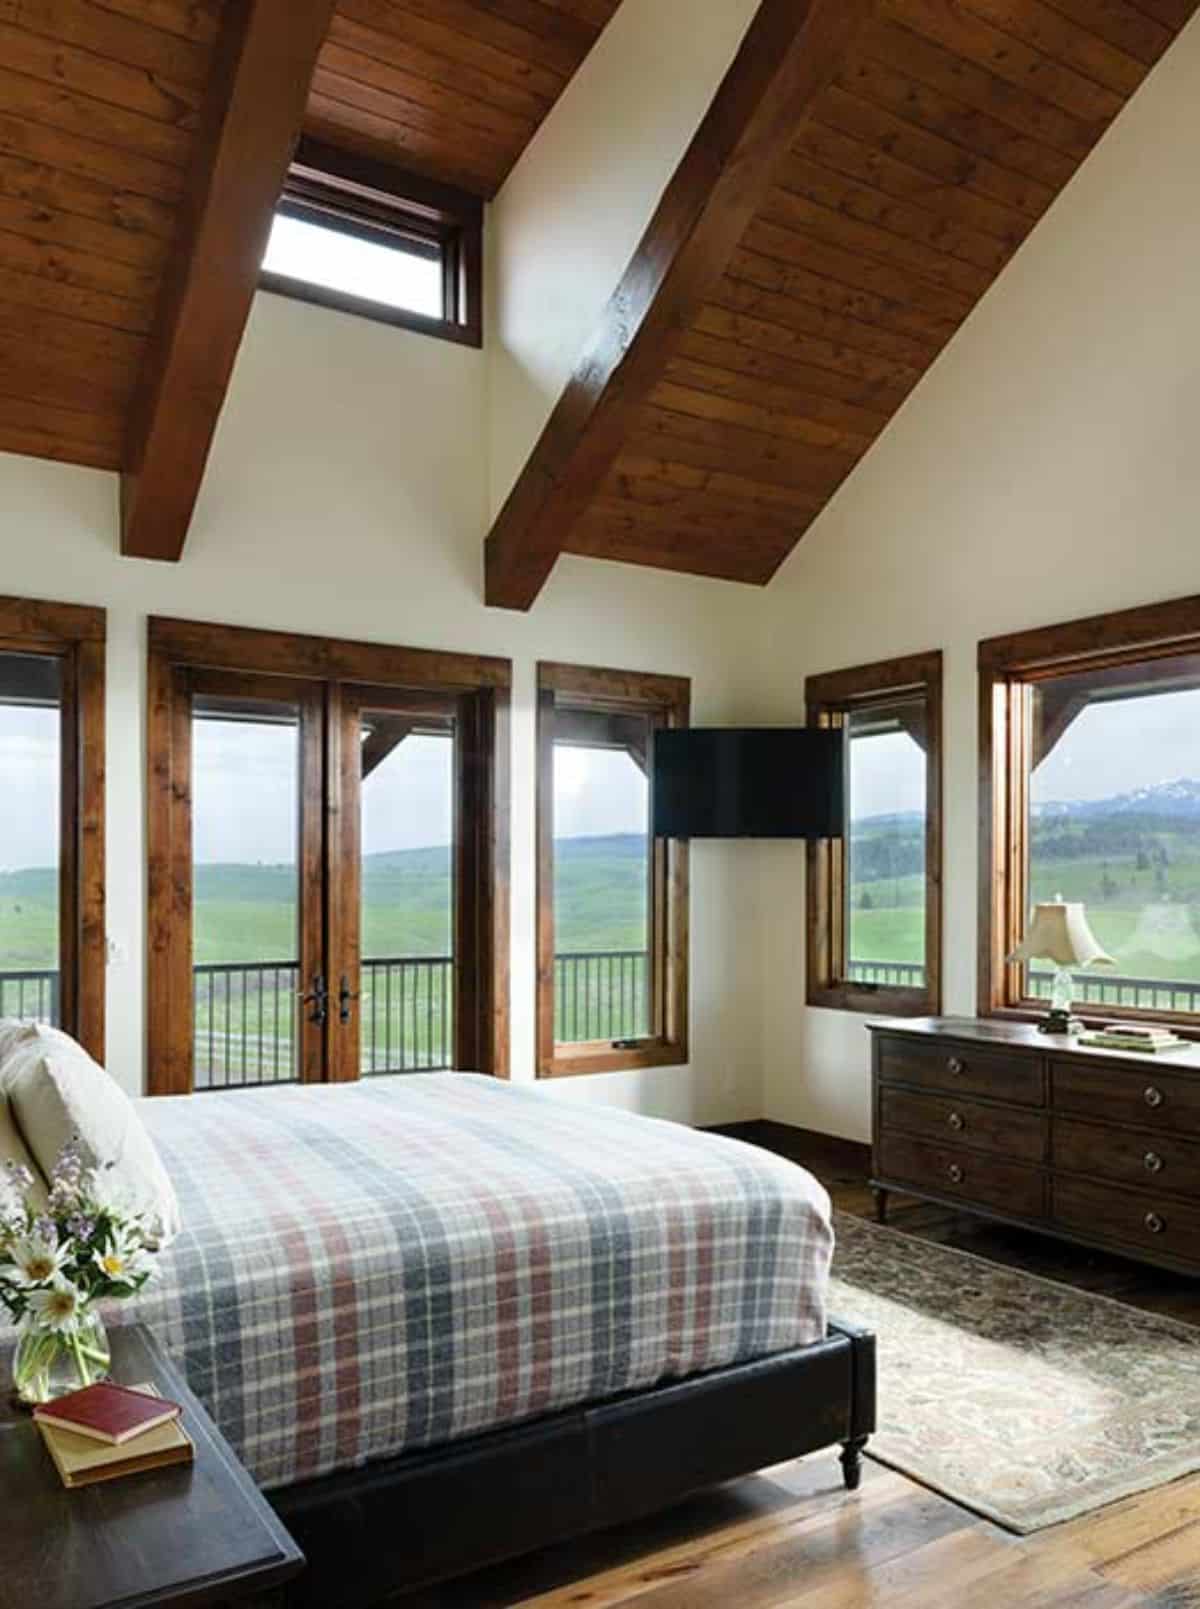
806, 653, 941, 1015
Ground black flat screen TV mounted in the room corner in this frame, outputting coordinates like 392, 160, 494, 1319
651, 726, 846, 838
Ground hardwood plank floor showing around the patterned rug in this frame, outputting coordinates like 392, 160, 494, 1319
396, 1125, 1200, 1609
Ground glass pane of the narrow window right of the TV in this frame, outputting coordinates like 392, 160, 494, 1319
846, 697, 927, 990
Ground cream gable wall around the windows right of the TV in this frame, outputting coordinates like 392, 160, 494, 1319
756, 19, 1200, 1139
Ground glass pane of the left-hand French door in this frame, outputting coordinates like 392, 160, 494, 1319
191, 697, 300, 1089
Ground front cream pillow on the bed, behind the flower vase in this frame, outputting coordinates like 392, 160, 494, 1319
6, 1028, 180, 1245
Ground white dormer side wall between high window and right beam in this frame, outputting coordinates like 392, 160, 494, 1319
487, 0, 758, 513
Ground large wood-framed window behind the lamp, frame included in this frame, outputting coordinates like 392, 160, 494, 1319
980, 600, 1200, 1027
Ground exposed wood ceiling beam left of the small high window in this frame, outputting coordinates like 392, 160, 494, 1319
121, 0, 333, 560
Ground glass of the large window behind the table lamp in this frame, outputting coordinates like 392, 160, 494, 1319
1028, 656, 1200, 1014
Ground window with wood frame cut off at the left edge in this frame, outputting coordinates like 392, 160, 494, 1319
0, 599, 105, 1060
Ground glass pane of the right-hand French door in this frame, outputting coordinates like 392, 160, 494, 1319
359, 711, 454, 1073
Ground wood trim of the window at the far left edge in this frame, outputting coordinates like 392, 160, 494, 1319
0, 597, 106, 1062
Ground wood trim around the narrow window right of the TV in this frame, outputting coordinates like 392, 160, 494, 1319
804, 652, 943, 1017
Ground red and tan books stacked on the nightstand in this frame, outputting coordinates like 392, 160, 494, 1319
34, 1381, 195, 1487
